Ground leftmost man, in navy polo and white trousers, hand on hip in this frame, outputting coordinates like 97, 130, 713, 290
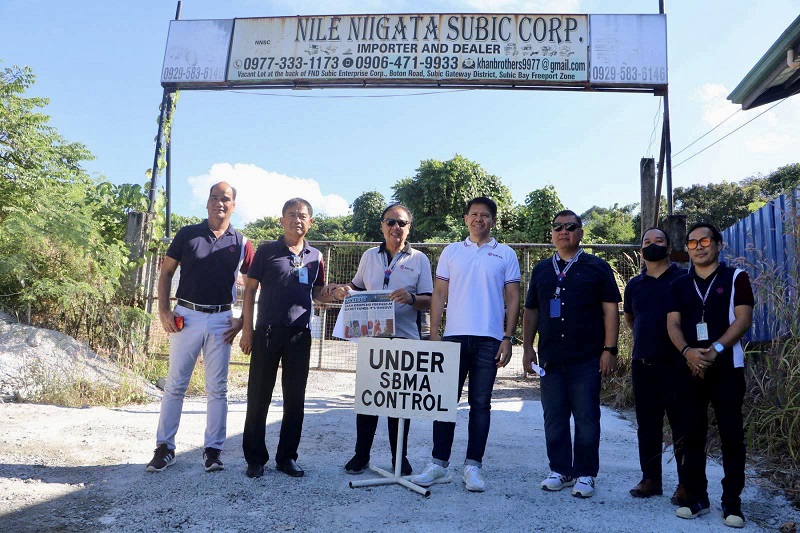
147, 182, 253, 472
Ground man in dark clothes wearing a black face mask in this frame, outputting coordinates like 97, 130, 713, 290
624, 228, 690, 505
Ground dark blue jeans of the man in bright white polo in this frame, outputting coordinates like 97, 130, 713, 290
432, 335, 500, 466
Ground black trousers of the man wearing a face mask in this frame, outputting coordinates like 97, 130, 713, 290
633, 359, 691, 484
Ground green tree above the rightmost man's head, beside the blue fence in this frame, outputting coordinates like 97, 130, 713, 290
673, 181, 764, 229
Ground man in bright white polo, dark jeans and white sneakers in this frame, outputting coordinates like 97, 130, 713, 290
411, 196, 520, 492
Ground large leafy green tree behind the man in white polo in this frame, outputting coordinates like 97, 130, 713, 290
392, 154, 513, 241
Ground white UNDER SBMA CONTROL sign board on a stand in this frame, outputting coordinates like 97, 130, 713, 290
355, 337, 460, 422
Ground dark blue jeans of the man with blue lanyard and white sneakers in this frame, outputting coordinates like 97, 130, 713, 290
540, 357, 600, 477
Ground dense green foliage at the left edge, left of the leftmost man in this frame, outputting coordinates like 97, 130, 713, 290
0, 61, 148, 370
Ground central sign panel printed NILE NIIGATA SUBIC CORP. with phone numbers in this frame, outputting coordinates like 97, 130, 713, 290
228, 14, 588, 84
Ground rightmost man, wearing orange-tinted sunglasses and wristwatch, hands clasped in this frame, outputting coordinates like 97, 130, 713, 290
667, 222, 755, 528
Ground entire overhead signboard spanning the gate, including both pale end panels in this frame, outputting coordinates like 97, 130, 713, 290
161, 13, 667, 90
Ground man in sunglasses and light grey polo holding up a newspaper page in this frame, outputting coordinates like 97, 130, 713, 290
322, 204, 433, 476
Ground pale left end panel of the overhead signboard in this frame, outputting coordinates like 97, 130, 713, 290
161, 20, 233, 86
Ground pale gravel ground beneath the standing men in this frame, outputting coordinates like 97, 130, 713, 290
0, 371, 800, 532
